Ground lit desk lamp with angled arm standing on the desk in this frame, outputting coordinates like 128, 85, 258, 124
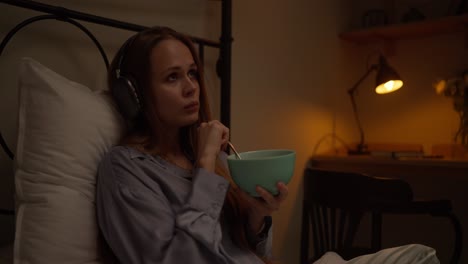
348, 55, 403, 155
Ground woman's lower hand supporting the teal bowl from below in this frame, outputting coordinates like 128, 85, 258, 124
240, 182, 288, 233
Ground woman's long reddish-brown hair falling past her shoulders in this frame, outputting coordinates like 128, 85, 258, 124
108, 27, 268, 263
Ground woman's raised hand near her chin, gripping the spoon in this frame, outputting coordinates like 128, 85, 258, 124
197, 120, 229, 171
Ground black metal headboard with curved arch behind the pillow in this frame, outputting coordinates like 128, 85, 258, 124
0, 0, 232, 159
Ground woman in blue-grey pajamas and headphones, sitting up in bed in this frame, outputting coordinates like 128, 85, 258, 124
97, 27, 288, 264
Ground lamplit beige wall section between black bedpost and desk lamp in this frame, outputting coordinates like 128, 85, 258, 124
232, 0, 357, 263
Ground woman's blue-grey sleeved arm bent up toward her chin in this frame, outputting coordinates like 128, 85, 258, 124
97, 150, 229, 263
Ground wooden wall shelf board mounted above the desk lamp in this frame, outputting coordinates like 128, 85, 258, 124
339, 14, 468, 48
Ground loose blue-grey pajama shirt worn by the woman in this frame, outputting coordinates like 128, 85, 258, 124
96, 146, 272, 264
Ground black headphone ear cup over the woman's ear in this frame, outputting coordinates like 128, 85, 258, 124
112, 76, 141, 122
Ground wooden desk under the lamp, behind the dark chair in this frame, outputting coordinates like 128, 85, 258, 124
307, 156, 468, 263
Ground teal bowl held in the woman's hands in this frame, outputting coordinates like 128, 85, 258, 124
227, 149, 296, 197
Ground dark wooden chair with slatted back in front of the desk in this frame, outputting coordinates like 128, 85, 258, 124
301, 168, 462, 264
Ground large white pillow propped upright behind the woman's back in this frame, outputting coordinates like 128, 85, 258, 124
14, 58, 124, 264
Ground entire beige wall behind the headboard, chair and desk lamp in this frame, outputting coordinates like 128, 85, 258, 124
0, 0, 468, 263
